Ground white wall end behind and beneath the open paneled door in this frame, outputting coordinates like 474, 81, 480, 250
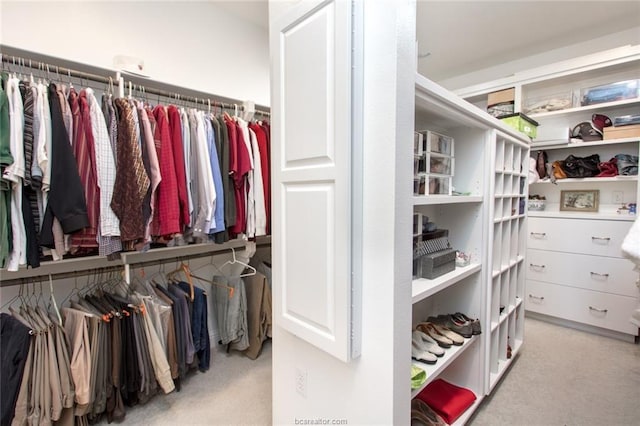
270, 0, 415, 425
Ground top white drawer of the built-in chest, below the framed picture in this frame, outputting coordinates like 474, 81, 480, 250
527, 217, 631, 257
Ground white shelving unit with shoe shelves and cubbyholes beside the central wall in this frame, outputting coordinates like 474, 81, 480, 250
407, 75, 529, 416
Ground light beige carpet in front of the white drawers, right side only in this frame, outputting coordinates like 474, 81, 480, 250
469, 318, 640, 426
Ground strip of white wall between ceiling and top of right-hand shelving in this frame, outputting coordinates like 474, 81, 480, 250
437, 26, 640, 91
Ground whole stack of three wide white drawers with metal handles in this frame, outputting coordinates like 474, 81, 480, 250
525, 217, 640, 336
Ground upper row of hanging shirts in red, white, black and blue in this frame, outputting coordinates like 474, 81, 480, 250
0, 62, 270, 270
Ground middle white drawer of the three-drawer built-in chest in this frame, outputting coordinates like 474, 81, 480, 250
526, 249, 640, 297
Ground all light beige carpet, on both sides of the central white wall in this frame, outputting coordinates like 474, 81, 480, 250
96, 318, 640, 426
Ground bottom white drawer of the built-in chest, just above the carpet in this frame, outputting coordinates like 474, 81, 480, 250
525, 280, 638, 335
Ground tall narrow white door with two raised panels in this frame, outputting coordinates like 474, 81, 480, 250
270, 0, 357, 361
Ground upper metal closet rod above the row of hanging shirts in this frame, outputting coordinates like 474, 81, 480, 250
0, 45, 271, 116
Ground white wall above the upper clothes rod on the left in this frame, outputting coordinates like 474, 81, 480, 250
0, 0, 270, 105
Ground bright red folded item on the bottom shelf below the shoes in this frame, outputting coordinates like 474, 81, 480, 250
416, 379, 476, 424
